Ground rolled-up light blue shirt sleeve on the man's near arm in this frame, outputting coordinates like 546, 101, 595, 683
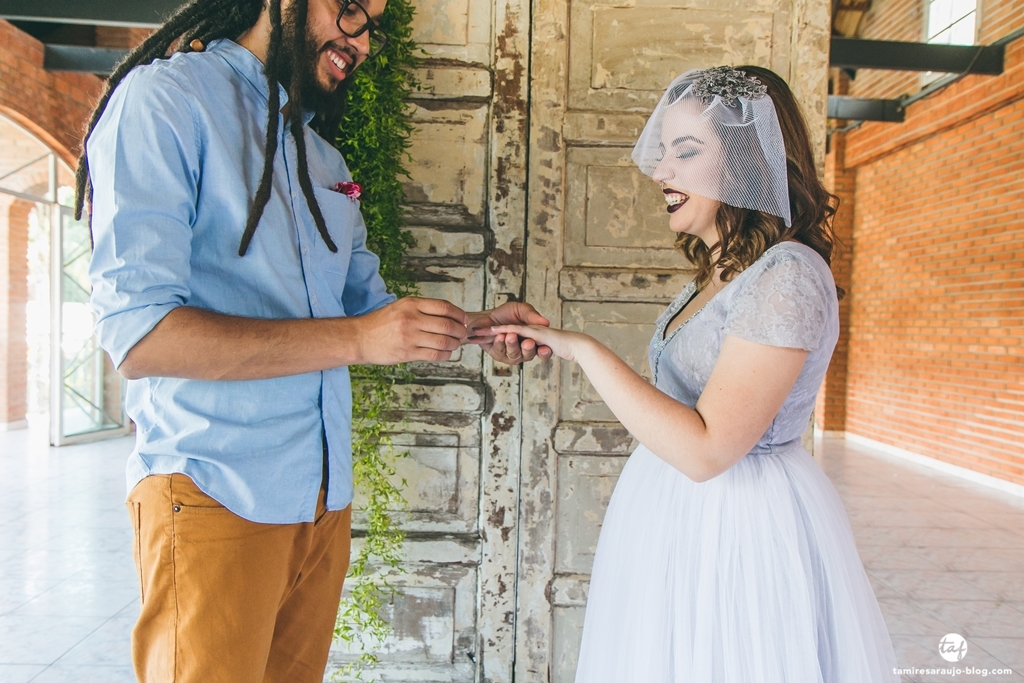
86, 62, 200, 367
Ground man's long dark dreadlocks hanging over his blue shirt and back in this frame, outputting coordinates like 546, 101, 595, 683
75, 0, 339, 256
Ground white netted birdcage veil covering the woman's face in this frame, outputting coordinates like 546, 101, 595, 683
633, 67, 793, 226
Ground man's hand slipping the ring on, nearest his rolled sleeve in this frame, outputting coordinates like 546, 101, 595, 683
352, 297, 469, 366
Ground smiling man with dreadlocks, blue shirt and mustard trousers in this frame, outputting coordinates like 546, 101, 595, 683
78, 0, 550, 683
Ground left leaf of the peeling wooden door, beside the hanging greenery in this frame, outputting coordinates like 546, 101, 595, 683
332, 0, 529, 683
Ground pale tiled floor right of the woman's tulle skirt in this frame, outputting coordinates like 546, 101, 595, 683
822, 439, 1024, 683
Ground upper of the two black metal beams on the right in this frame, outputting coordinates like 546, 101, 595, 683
829, 36, 1005, 76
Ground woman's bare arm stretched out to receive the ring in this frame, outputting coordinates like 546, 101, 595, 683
495, 326, 807, 481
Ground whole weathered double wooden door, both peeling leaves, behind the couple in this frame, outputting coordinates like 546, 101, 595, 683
334, 0, 828, 683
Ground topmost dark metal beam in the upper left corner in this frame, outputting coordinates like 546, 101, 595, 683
0, 0, 184, 28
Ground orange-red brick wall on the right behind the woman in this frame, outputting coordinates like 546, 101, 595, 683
823, 0, 1024, 484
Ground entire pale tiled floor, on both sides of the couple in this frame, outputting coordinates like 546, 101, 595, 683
0, 430, 1024, 683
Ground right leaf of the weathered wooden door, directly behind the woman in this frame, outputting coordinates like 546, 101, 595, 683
515, 0, 829, 683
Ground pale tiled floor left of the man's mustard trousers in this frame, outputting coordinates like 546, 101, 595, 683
0, 430, 138, 683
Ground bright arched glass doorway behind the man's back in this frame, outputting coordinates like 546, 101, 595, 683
0, 116, 129, 445
